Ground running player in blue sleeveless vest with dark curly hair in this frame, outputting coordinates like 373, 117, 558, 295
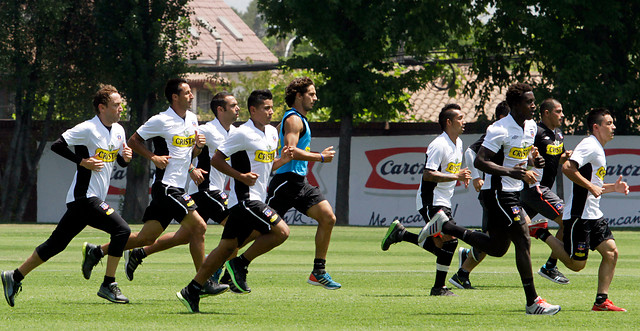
267, 77, 342, 290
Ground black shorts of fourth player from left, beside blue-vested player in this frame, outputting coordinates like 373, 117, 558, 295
222, 200, 282, 246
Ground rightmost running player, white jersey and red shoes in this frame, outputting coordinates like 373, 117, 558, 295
531, 108, 629, 311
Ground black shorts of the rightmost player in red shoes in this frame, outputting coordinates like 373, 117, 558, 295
562, 217, 614, 261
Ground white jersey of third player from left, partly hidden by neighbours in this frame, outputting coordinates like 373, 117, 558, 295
187, 118, 236, 194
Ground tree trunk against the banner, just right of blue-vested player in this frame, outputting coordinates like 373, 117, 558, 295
336, 114, 353, 225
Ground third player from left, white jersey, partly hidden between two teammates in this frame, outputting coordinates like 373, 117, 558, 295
124, 92, 240, 296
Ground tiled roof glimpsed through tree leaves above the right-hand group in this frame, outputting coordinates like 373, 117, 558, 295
405, 67, 507, 123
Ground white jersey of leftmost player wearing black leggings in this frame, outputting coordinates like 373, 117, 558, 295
62, 116, 126, 203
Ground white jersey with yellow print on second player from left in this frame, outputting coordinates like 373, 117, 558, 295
136, 107, 198, 189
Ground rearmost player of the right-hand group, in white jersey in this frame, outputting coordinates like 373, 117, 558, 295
381, 104, 471, 296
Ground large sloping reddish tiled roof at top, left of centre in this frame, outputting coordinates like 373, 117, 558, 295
189, 0, 278, 65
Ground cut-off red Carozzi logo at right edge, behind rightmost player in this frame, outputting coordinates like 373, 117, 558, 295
604, 148, 640, 192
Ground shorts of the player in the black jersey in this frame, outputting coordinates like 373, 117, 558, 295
520, 186, 564, 220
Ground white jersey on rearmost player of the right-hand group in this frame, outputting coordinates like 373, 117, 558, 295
416, 132, 462, 210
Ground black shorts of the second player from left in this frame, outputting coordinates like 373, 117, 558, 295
142, 182, 198, 229
